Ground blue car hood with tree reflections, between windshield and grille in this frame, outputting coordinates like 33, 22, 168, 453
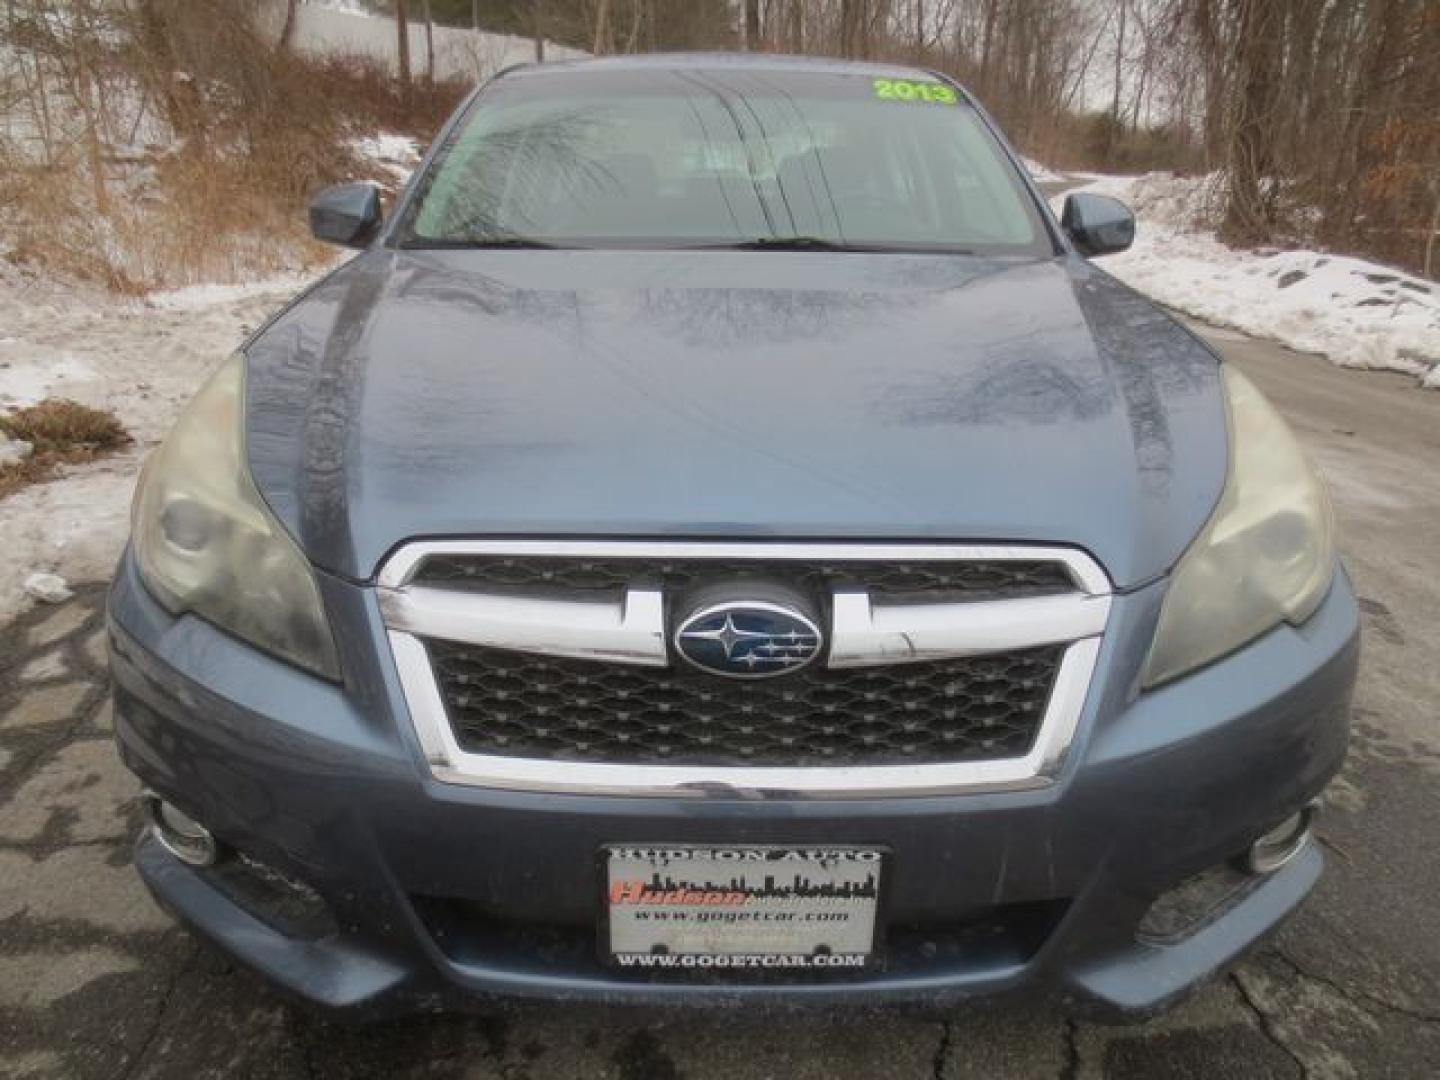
246, 249, 1227, 588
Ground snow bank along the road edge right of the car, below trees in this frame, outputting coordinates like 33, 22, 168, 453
1054, 173, 1440, 389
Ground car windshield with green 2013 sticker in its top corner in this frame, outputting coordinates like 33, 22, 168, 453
399, 69, 1053, 255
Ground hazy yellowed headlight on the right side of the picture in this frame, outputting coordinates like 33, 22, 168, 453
1145, 366, 1335, 687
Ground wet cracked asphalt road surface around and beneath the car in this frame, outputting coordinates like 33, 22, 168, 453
0, 330, 1440, 1080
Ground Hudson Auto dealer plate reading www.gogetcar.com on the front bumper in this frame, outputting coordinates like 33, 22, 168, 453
605, 844, 884, 971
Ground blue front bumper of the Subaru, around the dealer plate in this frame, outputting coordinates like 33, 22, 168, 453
109, 556, 1358, 1015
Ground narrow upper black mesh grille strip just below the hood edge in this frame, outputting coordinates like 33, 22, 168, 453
415, 554, 1076, 603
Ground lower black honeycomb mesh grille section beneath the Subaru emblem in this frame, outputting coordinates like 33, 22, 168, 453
425, 639, 1063, 766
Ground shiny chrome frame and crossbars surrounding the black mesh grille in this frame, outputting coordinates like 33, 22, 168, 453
379, 540, 1110, 798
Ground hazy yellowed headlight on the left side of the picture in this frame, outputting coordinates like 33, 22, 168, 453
131, 354, 340, 680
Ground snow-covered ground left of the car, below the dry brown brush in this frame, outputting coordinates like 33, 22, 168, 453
0, 268, 301, 621
